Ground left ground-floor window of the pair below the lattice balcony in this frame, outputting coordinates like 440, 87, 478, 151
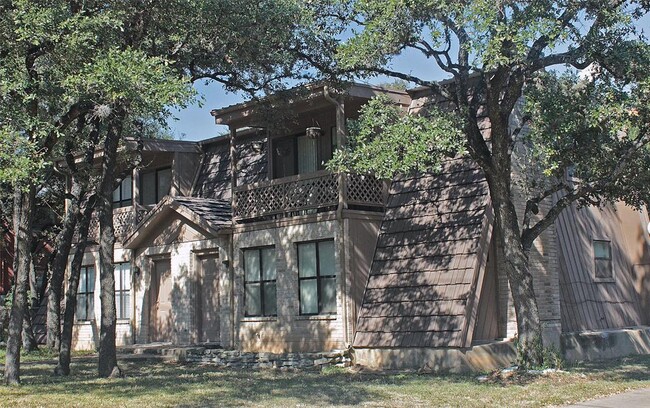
244, 247, 278, 316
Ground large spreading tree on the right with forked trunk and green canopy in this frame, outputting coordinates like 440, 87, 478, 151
318, 0, 650, 363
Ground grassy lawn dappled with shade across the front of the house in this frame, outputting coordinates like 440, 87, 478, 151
0, 356, 650, 407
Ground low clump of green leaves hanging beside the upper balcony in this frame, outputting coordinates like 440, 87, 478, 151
329, 97, 464, 178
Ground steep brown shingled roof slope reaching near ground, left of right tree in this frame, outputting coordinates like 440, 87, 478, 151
354, 159, 492, 348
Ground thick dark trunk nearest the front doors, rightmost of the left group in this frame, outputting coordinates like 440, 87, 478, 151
97, 115, 121, 377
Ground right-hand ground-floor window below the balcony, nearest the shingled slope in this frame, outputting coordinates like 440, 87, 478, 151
298, 240, 336, 315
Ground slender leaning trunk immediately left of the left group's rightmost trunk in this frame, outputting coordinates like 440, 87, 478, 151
54, 198, 95, 375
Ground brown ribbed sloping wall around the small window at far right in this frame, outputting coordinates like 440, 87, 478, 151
556, 203, 650, 332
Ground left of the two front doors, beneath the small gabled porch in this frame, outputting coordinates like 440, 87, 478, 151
149, 259, 173, 342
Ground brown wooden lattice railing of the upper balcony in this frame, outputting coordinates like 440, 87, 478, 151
233, 171, 387, 222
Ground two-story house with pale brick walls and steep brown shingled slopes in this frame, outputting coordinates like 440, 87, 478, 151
64, 85, 650, 366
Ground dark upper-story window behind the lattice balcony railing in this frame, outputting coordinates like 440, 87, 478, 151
273, 128, 335, 178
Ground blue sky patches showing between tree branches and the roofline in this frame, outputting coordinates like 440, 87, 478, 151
167, 15, 650, 141
